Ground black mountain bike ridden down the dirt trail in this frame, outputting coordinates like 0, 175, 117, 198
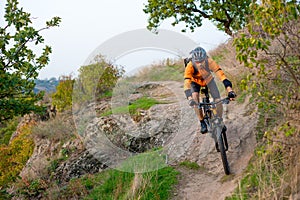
198, 90, 230, 175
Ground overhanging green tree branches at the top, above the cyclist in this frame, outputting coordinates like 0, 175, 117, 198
144, 0, 252, 35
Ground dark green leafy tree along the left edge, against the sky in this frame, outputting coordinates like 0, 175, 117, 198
0, 0, 61, 122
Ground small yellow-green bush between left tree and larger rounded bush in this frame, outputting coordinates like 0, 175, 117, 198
52, 76, 74, 111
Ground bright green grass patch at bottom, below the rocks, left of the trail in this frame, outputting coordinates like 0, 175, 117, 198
34, 148, 179, 200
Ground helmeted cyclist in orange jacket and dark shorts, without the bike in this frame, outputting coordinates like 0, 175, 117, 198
184, 47, 236, 134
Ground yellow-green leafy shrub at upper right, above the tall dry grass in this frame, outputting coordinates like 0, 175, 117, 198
234, 0, 300, 120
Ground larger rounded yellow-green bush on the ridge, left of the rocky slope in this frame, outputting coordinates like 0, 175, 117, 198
73, 55, 124, 104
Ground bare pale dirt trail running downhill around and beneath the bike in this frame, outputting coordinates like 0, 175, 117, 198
154, 82, 257, 200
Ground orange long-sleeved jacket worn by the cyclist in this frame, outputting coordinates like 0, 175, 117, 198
184, 58, 226, 90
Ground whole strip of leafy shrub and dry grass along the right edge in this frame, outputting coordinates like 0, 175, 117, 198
227, 0, 300, 199
